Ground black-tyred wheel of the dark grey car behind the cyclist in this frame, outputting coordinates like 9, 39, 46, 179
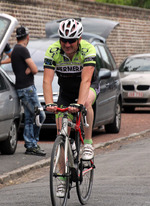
105, 101, 121, 133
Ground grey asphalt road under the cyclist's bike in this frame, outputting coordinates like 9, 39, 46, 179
0, 136, 150, 206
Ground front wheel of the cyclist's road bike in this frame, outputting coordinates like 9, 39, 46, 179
50, 135, 70, 206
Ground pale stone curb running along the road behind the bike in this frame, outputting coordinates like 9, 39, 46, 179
0, 129, 150, 184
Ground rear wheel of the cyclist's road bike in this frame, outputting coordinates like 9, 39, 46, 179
75, 132, 94, 205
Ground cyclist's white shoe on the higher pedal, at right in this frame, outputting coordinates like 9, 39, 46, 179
82, 144, 94, 160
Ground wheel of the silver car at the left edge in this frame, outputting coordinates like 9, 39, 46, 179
0, 122, 17, 154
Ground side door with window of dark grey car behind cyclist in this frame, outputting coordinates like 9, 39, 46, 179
95, 44, 117, 123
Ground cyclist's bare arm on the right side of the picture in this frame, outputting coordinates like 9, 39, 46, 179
77, 66, 94, 105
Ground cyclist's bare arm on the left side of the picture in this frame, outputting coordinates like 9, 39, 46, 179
43, 68, 55, 104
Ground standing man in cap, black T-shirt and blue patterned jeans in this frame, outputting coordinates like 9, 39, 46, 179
11, 26, 46, 156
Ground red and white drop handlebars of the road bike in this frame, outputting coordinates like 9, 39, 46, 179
35, 107, 89, 127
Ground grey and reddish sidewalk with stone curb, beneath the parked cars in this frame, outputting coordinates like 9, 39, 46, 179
0, 108, 150, 184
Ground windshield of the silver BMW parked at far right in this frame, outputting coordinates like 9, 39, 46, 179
119, 57, 150, 72
